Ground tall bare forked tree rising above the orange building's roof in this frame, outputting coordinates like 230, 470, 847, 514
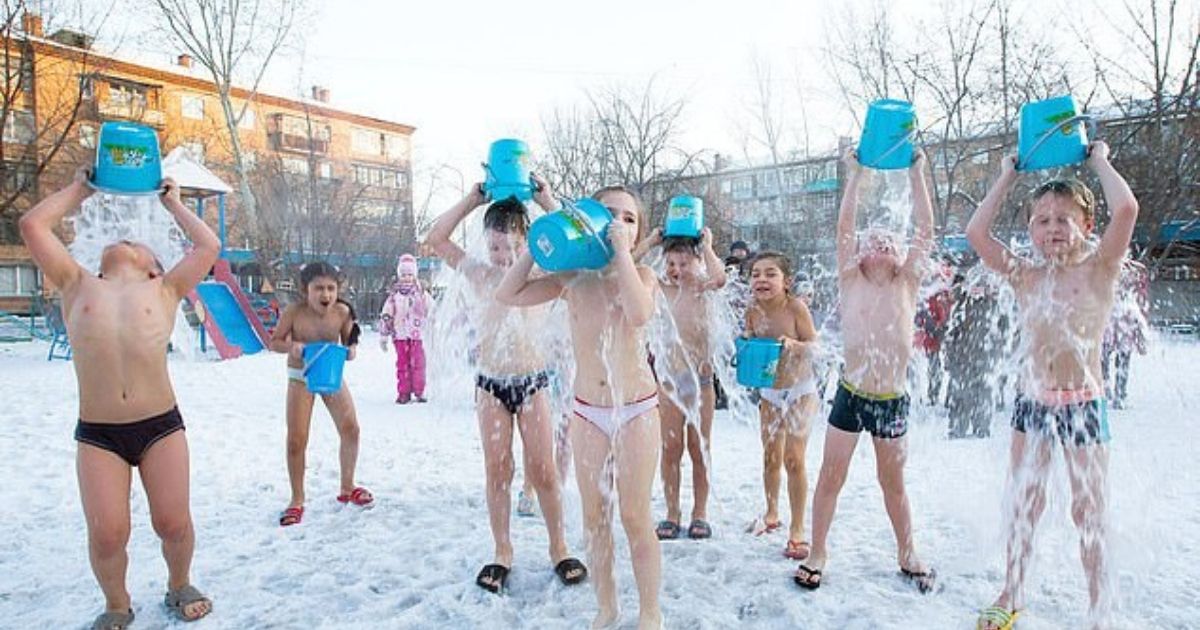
151, 0, 305, 221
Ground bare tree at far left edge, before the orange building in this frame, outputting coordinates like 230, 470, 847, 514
0, 0, 113, 244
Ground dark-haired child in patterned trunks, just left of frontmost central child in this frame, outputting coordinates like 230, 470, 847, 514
425, 172, 587, 593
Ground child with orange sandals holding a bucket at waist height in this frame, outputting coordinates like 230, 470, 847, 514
739, 252, 821, 560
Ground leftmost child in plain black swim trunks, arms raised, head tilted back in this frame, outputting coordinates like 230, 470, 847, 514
20, 169, 221, 630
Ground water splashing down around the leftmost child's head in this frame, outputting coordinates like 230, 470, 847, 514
68, 192, 198, 359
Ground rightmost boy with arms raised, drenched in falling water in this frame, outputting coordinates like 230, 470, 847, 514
967, 142, 1138, 630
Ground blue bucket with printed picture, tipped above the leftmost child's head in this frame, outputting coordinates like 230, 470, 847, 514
91, 122, 162, 194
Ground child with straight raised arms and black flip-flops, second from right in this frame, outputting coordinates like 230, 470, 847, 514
794, 149, 936, 593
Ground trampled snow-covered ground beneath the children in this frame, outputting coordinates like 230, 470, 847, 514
0, 331, 1200, 630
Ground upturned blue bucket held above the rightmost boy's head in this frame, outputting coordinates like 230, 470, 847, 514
1016, 96, 1091, 170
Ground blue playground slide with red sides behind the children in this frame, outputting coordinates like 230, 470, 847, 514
188, 260, 270, 359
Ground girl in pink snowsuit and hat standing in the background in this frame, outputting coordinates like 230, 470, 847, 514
379, 253, 432, 404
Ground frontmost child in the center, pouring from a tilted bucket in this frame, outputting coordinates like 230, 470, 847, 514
496, 186, 662, 629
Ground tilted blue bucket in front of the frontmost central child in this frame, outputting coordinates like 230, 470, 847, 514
528, 198, 612, 271
